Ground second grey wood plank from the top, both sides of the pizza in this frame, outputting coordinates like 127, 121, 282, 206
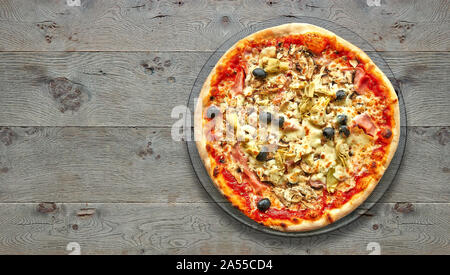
0, 52, 450, 126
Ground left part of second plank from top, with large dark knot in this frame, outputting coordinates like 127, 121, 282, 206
0, 53, 201, 126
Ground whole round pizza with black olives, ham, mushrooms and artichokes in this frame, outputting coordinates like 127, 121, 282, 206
194, 23, 400, 231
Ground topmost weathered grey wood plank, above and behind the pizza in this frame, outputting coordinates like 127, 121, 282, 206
0, 0, 450, 51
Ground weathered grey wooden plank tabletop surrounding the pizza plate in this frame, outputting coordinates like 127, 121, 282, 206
0, 0, 450, 254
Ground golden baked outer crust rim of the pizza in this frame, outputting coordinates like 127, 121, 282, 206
194, 23, 400, 232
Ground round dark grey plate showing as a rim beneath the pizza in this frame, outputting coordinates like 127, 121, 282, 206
186, 16, 407, 237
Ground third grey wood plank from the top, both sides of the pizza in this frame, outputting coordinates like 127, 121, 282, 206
0, 127, 450, 203
